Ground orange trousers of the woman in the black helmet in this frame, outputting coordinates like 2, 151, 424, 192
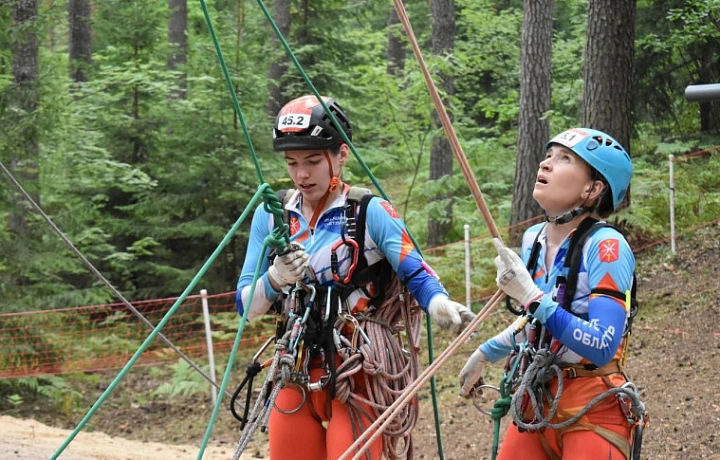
268, 369, 382, 460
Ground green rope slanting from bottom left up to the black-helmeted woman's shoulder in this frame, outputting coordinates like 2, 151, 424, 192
50, 184, 270, 460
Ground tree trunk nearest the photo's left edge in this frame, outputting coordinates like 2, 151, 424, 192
10, 0, 40, 235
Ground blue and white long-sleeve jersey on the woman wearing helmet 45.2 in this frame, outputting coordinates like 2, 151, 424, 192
237, 190, 448, 314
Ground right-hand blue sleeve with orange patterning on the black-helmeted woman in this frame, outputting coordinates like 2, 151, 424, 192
366, 197, 449, 312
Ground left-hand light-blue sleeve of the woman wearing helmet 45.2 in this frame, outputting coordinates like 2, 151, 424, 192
235, 204, 280, 315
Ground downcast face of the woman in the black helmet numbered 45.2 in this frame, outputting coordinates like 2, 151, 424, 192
285, 148, 347, 205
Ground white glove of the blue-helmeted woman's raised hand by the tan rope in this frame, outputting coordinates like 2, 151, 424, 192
493, 238, 543, 309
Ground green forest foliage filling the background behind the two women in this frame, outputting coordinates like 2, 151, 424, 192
0, 0, 720, 318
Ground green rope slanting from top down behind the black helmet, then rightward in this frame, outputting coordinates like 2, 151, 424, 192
257, 0, 445, 454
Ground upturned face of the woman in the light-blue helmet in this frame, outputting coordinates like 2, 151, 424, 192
533, 144, 602, 216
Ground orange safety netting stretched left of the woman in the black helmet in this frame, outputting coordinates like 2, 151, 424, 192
0, 292, 271, 378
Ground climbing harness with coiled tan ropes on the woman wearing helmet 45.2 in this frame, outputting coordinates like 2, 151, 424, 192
231, 187, 422, 459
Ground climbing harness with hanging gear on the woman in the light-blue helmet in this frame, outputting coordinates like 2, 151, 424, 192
474, 217, 648, 460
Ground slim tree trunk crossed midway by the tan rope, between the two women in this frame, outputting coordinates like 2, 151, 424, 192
427, 0, 455, 247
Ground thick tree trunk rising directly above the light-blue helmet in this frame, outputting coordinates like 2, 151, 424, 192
582, 0, 636, 153
